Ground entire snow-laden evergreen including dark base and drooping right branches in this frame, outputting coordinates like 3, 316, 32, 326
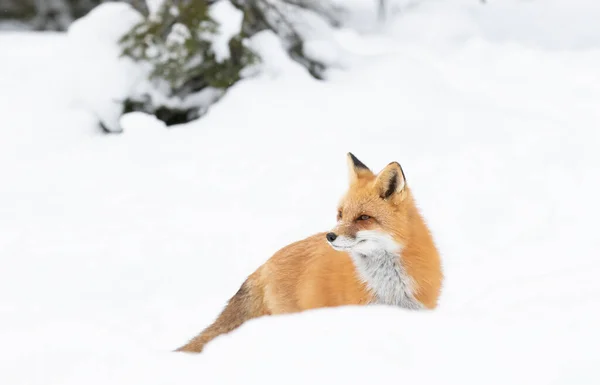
113, 0, 352, 128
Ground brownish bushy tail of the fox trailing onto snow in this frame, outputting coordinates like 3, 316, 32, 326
175, 279, 268, 353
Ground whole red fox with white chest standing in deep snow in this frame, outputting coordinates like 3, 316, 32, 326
176, 153, 443, 352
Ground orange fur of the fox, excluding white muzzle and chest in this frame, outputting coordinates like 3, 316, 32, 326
178, 154, 443, 352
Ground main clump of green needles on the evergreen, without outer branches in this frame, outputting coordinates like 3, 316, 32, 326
120, 0, 257, 96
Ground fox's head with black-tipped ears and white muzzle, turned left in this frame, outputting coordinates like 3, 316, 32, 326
326, 153, 412, 256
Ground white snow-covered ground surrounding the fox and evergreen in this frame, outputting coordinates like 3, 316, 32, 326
0, 0, 600, 385
